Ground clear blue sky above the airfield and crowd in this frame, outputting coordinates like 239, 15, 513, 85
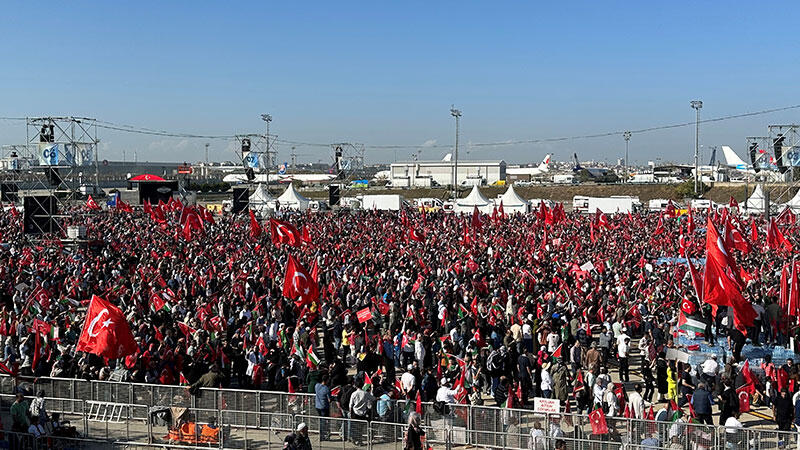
0, 1, 800, 163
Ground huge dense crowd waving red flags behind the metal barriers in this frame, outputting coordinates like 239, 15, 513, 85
0, 195, 800, 438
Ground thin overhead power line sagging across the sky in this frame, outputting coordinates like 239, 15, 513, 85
0, 105, 800, 150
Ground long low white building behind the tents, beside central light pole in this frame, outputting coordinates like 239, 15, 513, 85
389, 160, 506, 187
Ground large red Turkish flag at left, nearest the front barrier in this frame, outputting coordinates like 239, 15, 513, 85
76, 295, 138, 359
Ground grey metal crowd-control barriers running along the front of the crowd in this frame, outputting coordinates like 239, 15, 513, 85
0, 376, 800, 450
